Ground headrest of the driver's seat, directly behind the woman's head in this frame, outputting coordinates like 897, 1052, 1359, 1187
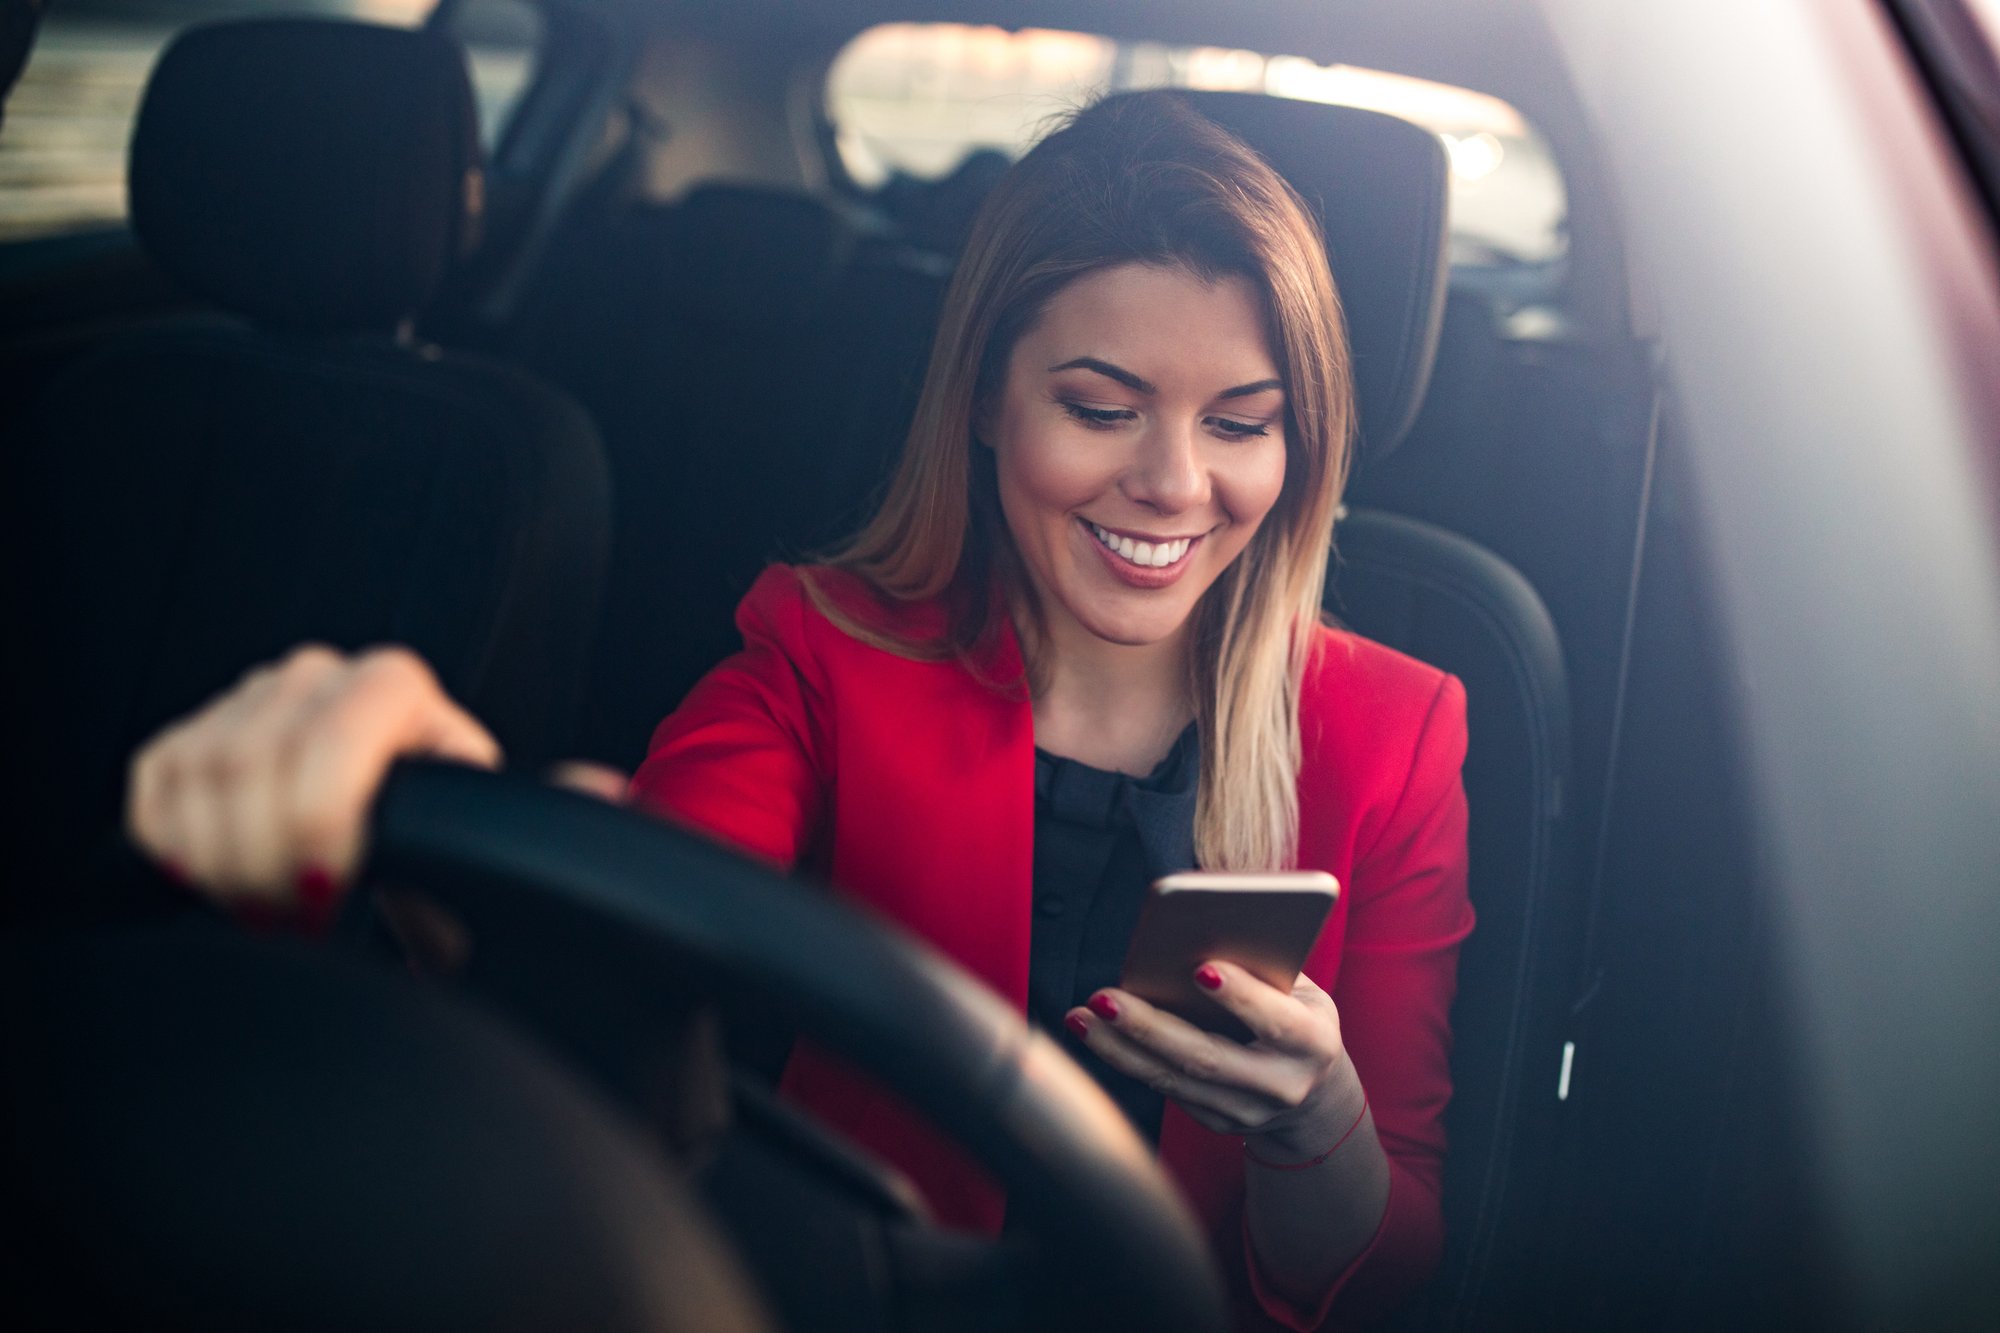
1188, 92, 1450, 456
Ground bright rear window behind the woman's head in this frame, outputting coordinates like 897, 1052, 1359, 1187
826, 24, 1566, 266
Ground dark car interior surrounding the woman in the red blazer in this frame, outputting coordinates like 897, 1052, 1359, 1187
0, 0, 1912, 1329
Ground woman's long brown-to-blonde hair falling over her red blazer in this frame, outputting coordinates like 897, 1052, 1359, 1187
806, 92, 1354, 871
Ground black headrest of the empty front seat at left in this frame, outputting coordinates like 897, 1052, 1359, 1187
132, 18, 480, 332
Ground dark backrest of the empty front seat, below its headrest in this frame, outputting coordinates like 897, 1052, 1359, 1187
20, 318, 606, 795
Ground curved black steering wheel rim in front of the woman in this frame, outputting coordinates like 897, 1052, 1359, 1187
364, 765, 1224, 1333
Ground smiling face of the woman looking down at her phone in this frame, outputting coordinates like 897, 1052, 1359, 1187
980, 264, 1284, 646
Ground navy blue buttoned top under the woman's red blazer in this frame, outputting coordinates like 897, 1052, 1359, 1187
1028, 725, 1202, 1143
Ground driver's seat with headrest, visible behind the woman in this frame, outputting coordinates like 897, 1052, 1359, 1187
1160, 92, 1572, 1329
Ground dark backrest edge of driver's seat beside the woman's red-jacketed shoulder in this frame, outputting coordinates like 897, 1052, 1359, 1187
1328, 510, 1574, 1327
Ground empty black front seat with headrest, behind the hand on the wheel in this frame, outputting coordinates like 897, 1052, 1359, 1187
4, 20, 610, 912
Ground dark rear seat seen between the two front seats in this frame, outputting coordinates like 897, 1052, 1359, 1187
514, 184, 948, 767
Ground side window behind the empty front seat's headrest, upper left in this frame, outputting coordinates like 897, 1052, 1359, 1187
0, 0, 540, 242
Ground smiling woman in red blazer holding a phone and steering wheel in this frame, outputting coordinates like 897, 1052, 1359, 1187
130, 94, 1472, 1327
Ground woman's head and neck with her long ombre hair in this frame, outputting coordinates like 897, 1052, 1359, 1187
808, 94, 1354, 869
